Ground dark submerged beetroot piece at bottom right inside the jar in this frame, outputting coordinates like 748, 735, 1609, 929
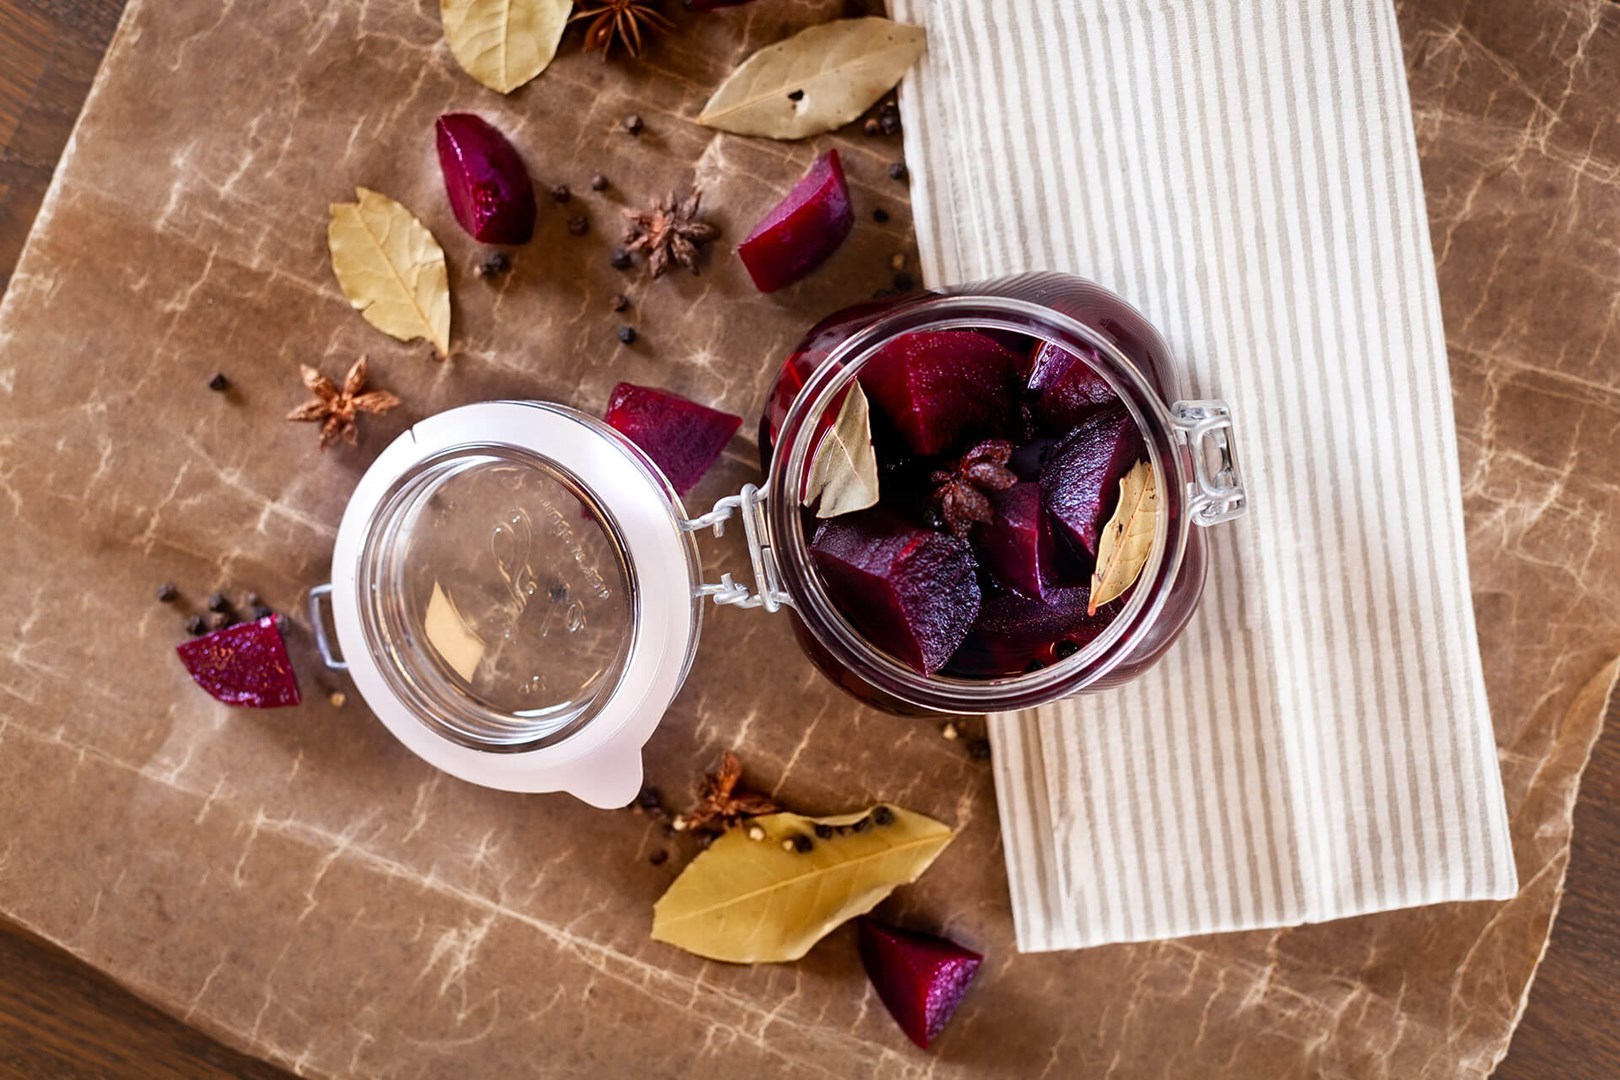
946, 585, 1121, 678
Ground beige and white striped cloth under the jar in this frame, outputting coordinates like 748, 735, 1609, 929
891, 0, 1516, 950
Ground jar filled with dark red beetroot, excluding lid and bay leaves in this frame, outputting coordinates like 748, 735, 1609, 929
760, 274, 1241, 712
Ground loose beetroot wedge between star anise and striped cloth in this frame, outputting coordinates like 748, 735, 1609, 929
737, 151, 855, 293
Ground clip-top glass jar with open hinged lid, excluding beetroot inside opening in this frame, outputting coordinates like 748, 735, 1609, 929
309, 274, 1246, 806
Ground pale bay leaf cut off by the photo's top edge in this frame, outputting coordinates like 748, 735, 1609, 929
439, 0, 573, 94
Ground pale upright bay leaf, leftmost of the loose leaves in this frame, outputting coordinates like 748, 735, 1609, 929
326, 188, 450, 356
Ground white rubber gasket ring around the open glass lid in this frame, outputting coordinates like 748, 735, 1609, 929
332, 402, 698, 808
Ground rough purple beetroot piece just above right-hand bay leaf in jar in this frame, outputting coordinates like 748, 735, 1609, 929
1040, 408, 1147, 557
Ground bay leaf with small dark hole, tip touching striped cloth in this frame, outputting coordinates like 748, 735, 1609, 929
698, 18, 923, 139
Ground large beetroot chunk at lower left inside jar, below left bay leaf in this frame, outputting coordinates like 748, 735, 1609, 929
810, 508, 978, 675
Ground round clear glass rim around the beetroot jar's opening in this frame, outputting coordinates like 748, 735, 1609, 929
770, 290, 1187, 712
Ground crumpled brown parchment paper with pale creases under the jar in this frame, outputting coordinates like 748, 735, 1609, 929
0, 0, 1620, 1077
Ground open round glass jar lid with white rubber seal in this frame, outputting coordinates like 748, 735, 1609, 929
330, 402, 701, 806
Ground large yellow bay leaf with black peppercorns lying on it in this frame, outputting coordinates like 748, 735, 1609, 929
653, 806, 956, 963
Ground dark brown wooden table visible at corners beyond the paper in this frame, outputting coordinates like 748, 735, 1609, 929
0, 0, 1620, 1080
